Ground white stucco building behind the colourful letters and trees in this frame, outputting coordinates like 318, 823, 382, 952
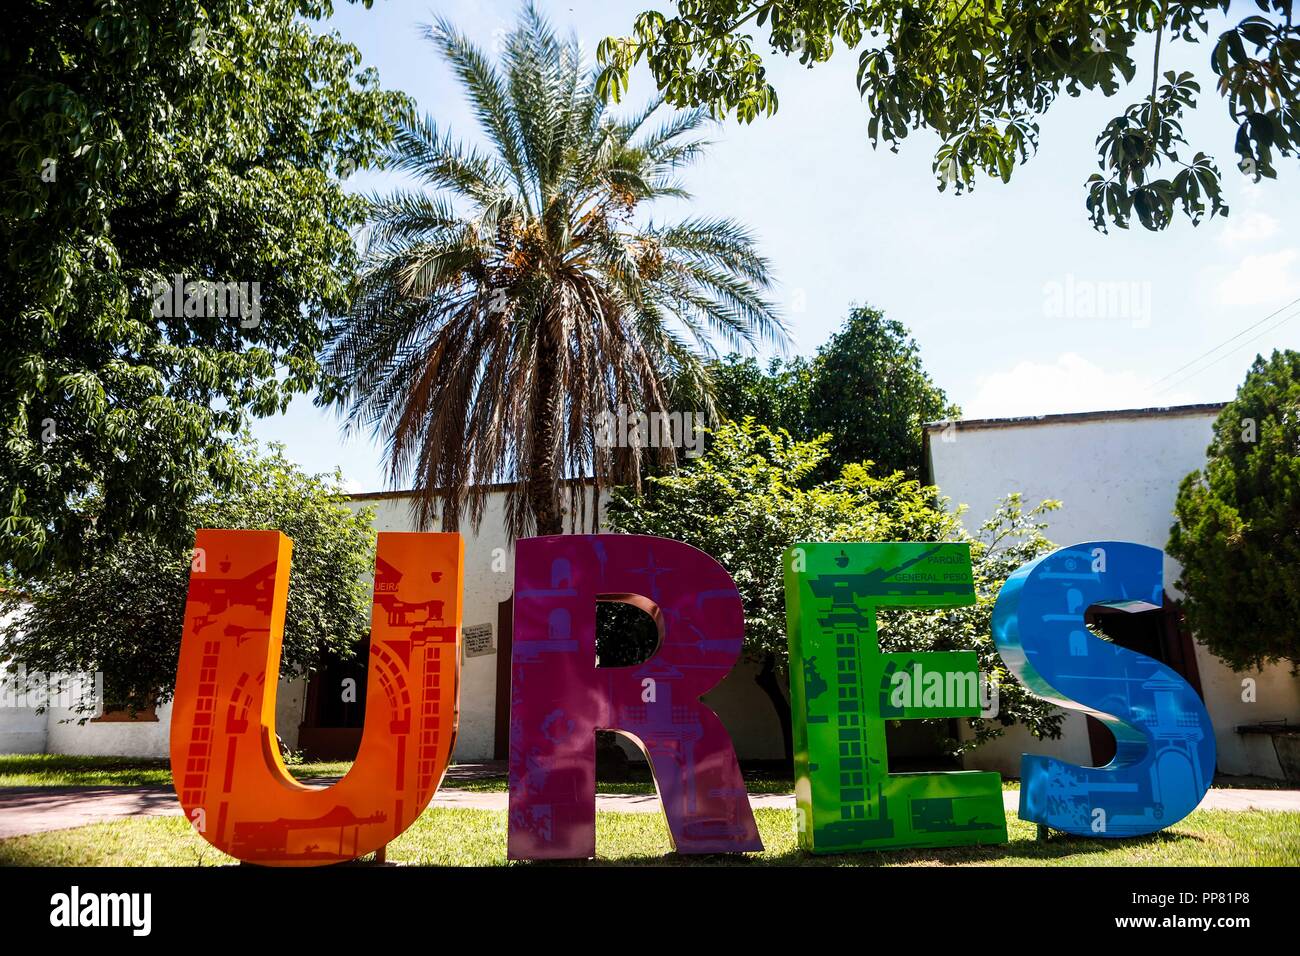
0, 405, 1300, 778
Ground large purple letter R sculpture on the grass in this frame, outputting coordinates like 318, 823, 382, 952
507, 535, 763, 860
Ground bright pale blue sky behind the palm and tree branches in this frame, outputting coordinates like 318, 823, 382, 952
255, 0, 1300, 490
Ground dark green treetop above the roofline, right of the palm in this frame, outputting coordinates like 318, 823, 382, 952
712, 307, 961, 480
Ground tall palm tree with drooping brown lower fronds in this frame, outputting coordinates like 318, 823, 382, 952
324, 7, 785, 536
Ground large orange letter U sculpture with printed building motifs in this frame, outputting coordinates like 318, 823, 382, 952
172, 531, 464, 866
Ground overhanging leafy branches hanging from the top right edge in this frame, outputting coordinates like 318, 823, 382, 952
597, 0, 1300, 230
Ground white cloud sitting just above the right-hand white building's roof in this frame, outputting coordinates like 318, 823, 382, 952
962, 352, 1190, 419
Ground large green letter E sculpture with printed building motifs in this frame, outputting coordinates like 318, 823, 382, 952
784, 544, 1006, 853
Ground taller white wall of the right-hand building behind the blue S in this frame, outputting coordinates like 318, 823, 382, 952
928, 406, 1300, 778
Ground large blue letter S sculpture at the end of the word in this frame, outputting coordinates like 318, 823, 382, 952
993, 541, 1214, 836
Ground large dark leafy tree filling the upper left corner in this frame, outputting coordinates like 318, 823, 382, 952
0, 0, 407, 567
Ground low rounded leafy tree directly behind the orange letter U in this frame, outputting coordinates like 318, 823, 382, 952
0, 441, 376, 711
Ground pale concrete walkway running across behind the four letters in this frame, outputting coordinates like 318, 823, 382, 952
0, 778, 1300, 839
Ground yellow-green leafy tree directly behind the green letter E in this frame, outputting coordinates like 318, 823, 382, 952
602, 420, 1061, 752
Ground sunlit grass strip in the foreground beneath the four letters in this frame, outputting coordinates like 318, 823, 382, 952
0, 809, 1300, 866
